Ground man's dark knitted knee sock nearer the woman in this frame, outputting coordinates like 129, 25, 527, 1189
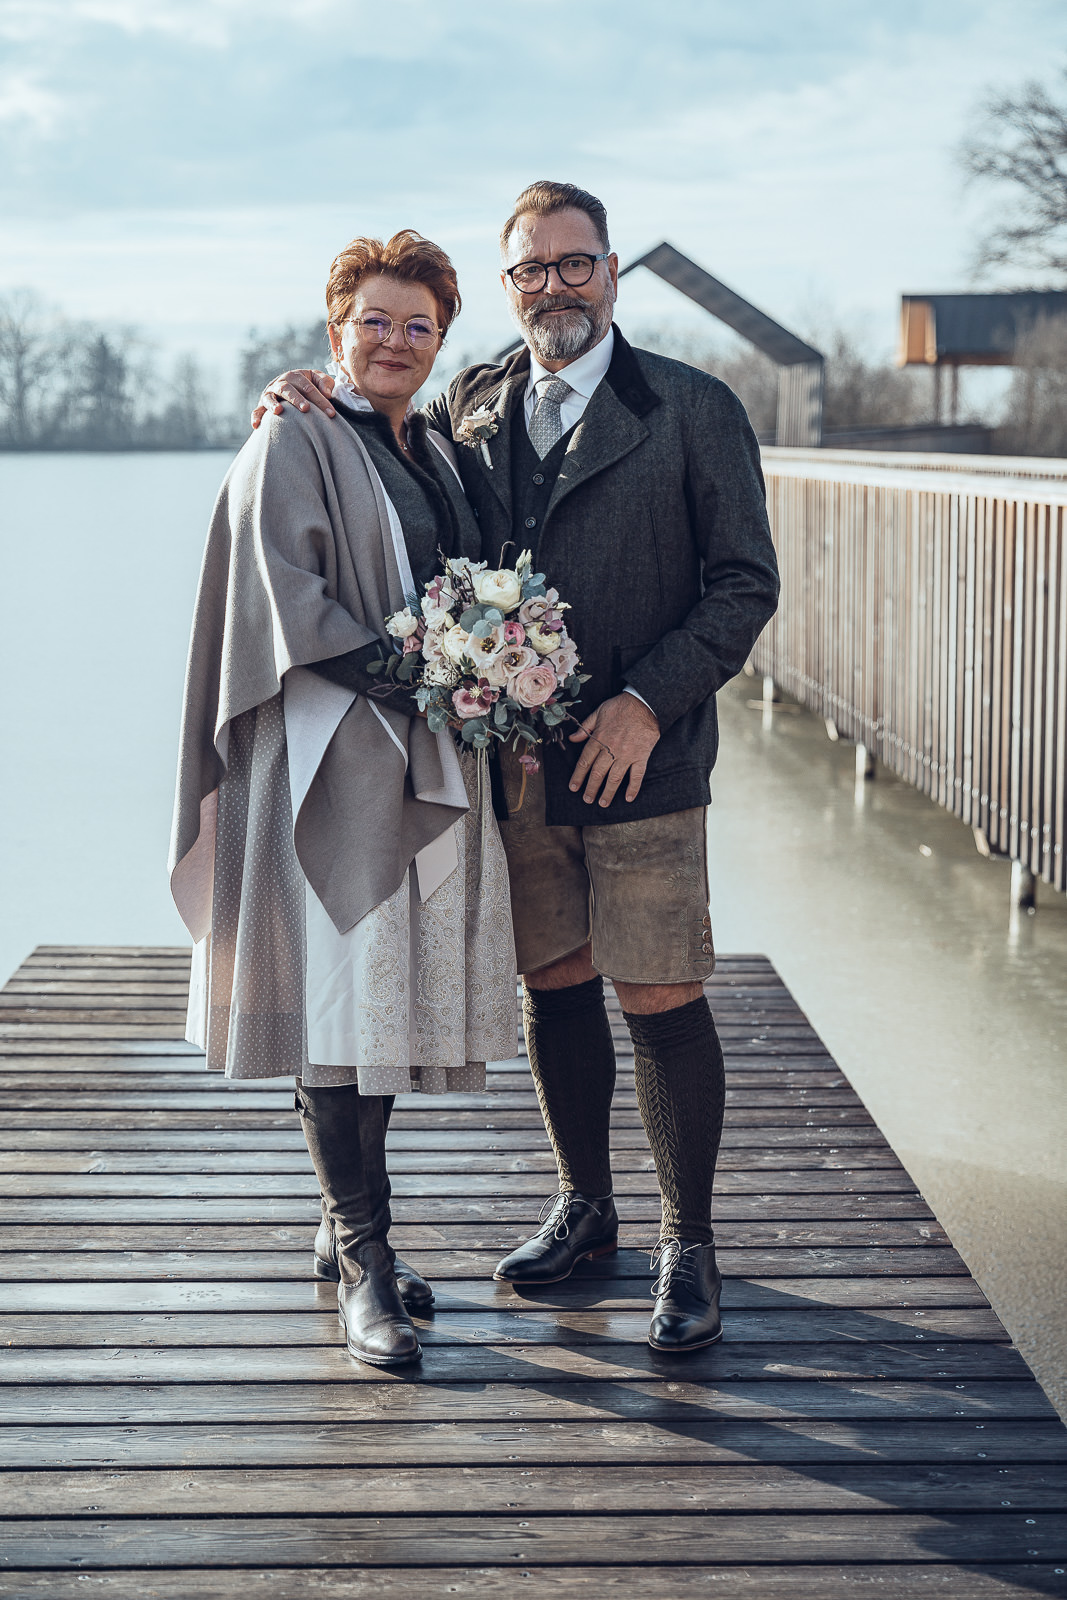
523, 978, 614, 1197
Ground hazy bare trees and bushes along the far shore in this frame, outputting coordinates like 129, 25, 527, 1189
0, 290, 1067, 456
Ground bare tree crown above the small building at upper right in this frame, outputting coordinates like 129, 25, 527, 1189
960, 69, 1067, 274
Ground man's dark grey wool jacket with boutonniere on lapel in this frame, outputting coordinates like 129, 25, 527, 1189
427, 328, 779, 826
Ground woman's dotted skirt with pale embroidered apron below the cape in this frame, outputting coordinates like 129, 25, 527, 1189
189, 694, 517, 1094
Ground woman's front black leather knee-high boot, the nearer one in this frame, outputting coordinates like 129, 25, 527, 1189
296, 1083, 422, 1366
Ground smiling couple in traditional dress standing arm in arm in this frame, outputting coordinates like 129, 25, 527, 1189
171, 182, 777, 1365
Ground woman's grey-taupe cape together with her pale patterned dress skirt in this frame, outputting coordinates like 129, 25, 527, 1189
171, 403, 517, 1094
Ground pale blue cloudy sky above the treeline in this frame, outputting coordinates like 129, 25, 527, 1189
0, 0, 1067, 393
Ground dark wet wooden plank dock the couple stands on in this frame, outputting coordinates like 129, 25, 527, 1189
0, 947, 1067, 1600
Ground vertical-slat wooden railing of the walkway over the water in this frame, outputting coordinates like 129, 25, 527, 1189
752, 448, 1067, 890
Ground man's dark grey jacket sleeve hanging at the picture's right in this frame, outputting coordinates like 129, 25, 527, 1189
625, 382, 779, 730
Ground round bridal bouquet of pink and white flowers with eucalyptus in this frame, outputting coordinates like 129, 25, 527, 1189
379, 550, 589, 773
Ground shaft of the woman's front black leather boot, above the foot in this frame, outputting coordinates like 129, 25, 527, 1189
296, 1083, 392, 1282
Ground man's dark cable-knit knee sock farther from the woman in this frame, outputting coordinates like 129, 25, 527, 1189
624, 995, 726, 1245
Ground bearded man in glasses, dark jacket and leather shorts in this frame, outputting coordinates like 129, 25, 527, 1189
259, 182, 777, 1350
